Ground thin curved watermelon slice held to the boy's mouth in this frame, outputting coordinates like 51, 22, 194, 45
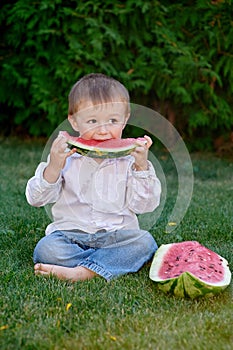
59, 131, 146, 158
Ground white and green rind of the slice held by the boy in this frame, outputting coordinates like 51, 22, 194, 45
67, 140, 140, 158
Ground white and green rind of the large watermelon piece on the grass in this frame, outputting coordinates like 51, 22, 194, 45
149, 243, 231, 299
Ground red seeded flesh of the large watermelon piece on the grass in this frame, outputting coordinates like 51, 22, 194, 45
158, 242, 224, 283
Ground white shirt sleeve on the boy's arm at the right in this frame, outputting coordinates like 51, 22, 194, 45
127, 161, 161, 214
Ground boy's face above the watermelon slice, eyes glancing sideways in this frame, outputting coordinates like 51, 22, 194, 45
68, 102, 129, 140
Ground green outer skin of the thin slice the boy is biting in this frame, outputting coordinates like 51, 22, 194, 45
67, 142, 136, 158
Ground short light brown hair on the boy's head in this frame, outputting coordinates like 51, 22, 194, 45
68, 73, 130, 115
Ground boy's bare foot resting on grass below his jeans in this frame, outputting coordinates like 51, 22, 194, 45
34, 263, 97, 282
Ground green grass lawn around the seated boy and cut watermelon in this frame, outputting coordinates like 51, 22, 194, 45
0, 140, 233, 350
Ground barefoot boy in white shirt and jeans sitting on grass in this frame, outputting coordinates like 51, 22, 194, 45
26, 74, 161, 281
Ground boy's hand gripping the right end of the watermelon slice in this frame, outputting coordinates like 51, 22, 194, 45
131, 135, 153, 171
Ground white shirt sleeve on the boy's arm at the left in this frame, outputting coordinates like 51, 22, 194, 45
25, 162, 62, 207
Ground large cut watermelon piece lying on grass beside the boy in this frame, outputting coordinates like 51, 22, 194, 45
149, 241, 231, 298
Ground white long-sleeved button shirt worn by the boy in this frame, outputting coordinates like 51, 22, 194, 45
26, 153, 161, 234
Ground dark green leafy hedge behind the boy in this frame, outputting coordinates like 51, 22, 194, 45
0, 0, 233, 147
